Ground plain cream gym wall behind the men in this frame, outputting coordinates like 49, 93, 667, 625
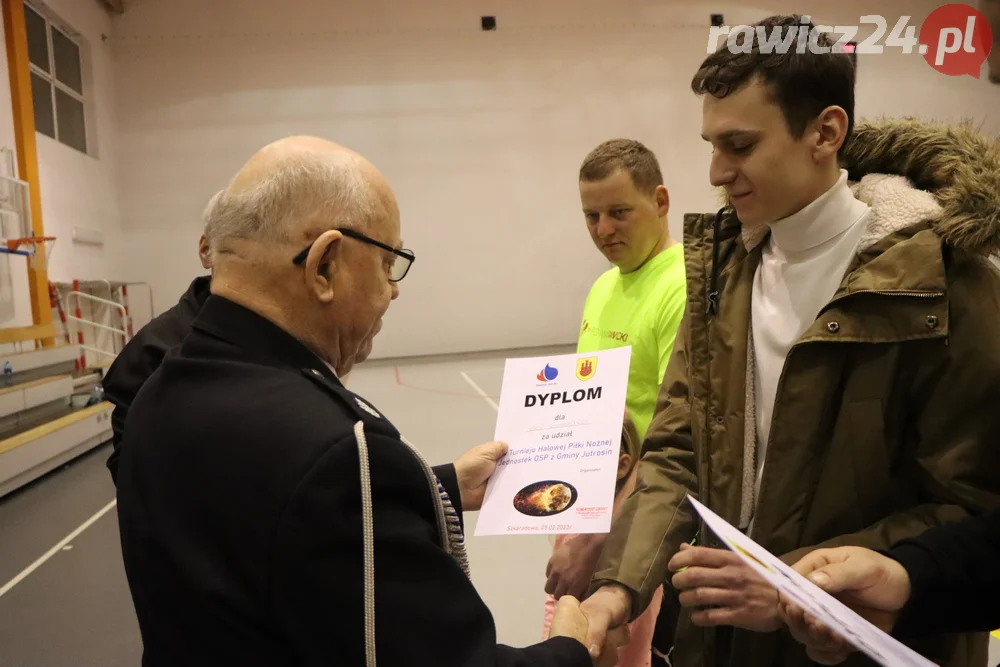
0, 0, 1000, 357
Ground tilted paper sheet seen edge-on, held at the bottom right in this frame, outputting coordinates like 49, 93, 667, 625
688, 496, 937, 667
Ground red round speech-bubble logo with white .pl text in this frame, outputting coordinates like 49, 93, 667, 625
919, 4, 993, 79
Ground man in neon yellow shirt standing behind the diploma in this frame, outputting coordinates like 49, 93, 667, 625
545, 139, 687, 616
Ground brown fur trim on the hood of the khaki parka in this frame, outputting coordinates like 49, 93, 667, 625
843, 118, 1000, 255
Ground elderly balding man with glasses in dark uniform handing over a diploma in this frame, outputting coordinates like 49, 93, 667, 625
118, 137, 624, 667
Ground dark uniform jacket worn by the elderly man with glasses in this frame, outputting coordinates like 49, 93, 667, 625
118, 295, 592, 667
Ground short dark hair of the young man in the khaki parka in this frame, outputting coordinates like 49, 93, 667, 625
691, 14, 856, 151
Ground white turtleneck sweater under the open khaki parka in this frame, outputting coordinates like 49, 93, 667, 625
751, 169, 871, 506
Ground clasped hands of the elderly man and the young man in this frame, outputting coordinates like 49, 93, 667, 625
549, 586, 629, 667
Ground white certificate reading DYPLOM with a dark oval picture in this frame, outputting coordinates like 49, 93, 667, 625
475, 346, 632, 535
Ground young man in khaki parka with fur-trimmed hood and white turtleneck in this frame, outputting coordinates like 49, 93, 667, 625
584, 16, 1000, 667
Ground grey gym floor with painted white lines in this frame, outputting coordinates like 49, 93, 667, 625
0, 348, 1000, 667
